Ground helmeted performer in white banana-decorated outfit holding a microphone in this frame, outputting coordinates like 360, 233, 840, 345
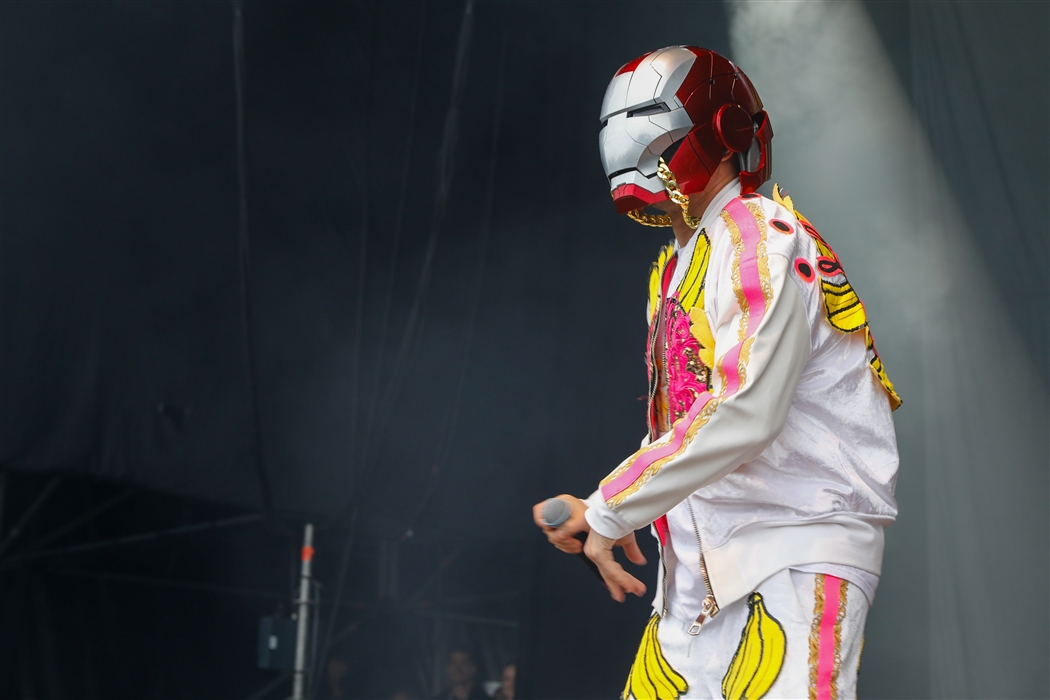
534, 46, 900, 700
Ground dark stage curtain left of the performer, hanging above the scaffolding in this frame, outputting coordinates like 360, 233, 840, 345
2, 3, 728, 536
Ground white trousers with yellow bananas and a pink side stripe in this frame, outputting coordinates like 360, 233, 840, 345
623, 570, 868, 700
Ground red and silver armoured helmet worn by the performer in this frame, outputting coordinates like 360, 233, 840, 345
599, 46, 773, 214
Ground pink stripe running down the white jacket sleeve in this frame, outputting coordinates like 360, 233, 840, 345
602, 198, 765, 501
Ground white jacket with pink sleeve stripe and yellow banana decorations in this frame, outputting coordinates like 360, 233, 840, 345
586, 178, 900, 633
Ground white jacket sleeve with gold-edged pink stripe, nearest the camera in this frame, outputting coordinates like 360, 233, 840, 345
586, 217, 811, 538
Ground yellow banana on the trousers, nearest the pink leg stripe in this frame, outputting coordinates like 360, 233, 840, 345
722, 592, 788, 700
